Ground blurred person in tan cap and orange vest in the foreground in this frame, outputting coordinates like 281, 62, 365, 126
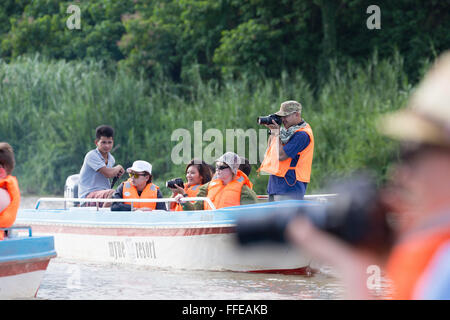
286, 51, 450, 300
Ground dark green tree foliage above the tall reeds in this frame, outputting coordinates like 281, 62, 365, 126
0, 0, 450, 84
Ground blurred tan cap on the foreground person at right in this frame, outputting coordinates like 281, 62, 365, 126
378, 51, 450, 147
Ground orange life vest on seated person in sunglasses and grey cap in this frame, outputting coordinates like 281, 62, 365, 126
203, 173, 250, 210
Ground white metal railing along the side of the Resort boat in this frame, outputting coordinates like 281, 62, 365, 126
35, 197, 216, 211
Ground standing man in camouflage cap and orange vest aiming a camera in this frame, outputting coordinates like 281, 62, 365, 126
258, 101, 314, 201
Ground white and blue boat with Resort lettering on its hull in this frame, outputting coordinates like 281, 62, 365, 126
17, 198, 334, 275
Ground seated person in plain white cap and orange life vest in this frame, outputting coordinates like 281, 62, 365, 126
111, 160, 166, 211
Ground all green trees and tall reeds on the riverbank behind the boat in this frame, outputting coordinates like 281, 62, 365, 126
0, 0, 450, 195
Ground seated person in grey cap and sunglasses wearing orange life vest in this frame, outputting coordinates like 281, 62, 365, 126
175, 152, 257, 211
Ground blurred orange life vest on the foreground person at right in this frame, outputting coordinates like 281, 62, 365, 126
386, 221, 450, 300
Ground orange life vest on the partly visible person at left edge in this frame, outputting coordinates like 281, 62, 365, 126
0, 175, 20, 240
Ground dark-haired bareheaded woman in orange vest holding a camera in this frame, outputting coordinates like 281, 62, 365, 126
170, 159, 212, 211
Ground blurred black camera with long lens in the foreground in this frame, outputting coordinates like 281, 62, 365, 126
236, 174, 392, 251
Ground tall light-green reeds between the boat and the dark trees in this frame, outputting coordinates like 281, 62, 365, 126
0, 55, 412, 195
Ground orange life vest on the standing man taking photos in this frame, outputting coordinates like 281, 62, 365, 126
258, 123, 314, 182
